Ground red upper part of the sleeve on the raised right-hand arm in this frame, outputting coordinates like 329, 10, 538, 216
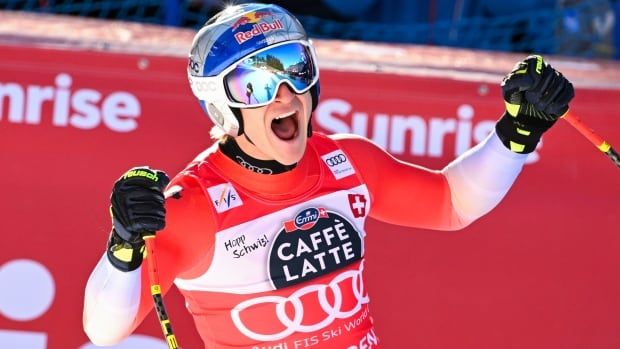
334, 135, 463, 230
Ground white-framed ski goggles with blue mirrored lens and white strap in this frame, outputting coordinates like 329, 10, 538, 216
190, 41, 319, 108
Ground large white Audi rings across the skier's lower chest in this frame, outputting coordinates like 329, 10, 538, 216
231, 262, 370, 342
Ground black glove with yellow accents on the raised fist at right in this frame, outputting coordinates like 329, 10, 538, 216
495, 55, 575, 154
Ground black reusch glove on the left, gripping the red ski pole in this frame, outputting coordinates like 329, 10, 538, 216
107, 167, 170, 271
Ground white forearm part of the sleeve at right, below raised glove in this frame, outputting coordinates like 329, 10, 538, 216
442, 131, 527, 224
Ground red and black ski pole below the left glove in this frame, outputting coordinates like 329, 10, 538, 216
142, 232, 179, 349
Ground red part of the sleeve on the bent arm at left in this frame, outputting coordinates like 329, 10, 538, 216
134, 175, 215, 327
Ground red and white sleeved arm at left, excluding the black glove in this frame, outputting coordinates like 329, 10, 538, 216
83, 170, 214, 345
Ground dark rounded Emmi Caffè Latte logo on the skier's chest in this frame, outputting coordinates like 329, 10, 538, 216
269, 207, 363, 289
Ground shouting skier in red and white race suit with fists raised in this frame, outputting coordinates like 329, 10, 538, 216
84, 4, 574, 349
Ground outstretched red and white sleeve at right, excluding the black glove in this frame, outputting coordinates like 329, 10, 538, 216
336, 129, 526, 230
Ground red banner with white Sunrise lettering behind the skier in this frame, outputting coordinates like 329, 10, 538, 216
0, 46, 620, 349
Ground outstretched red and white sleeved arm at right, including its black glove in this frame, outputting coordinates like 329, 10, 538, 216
338, 56, 574, 229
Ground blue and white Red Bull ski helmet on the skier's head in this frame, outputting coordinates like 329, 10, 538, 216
187, 3, 319, 136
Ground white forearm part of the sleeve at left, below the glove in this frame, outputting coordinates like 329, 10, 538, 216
83, 254, 141, 345
